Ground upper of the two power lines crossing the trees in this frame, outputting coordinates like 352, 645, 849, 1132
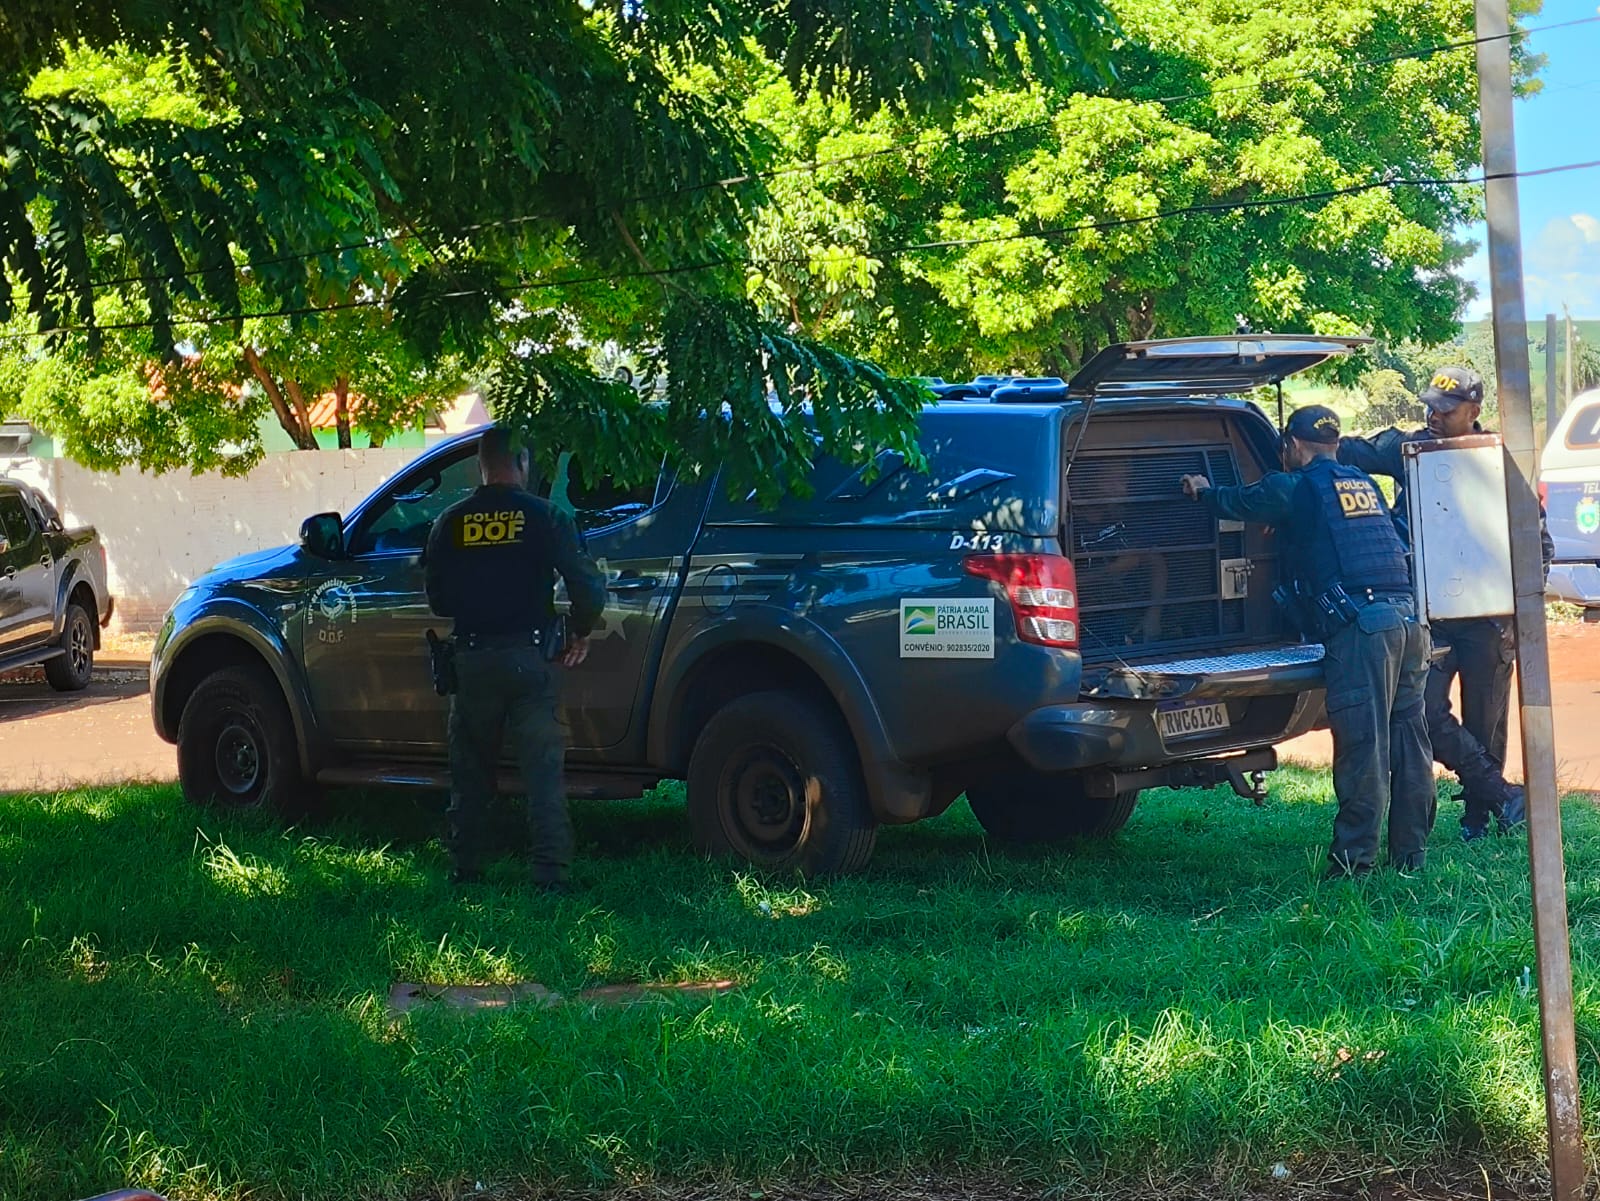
68, 14, 1600, 299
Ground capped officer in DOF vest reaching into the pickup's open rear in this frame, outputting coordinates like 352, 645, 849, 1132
1181, 405, 1435, 878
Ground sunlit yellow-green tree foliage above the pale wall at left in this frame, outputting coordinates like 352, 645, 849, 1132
0, 48, 462, 472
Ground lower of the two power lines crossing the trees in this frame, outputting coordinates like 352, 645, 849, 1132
12, 158, 1600, 342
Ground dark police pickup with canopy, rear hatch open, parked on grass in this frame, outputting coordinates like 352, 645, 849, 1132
152, 336, 1365, 872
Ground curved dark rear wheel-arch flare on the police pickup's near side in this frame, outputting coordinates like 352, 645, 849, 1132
646, 604, 933, 822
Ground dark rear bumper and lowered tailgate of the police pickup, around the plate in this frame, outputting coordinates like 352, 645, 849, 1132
1006, 644, 1323, 795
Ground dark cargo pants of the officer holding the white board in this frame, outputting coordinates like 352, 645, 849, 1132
1427, 617, 1515, 830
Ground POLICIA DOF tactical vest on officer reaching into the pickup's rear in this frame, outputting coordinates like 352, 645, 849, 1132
1294, 459, 1411, 595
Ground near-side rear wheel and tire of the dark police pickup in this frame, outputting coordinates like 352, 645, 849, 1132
688, 691, 878, 876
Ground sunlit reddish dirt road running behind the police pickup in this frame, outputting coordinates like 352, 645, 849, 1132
0, 625, 1600, 792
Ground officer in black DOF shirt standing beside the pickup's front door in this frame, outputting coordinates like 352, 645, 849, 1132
424, 425, 605, 892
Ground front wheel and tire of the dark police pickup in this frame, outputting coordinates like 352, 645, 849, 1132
178, 667, 312, 817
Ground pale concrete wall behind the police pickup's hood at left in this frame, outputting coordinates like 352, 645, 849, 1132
0, 446, 421, 630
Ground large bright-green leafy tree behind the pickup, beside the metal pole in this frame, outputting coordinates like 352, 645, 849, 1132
732, 0, 1538, 382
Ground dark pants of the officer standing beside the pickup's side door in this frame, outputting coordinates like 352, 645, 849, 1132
446, 640, 573, 884
